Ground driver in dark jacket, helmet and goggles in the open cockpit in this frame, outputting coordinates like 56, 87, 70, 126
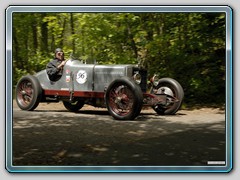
46, 48, 66, 81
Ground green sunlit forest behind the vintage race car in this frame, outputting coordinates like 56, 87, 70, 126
12, 12, 226, 107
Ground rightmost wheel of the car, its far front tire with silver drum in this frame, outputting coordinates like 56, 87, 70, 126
151, 78, 184, 115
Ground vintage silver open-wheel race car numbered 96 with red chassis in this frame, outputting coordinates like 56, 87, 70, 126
16, 59, 184, 120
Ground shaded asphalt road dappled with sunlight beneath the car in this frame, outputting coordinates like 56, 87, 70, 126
12, 104, 226, 166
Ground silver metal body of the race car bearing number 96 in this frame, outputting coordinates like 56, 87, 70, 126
35, 60, 143, 92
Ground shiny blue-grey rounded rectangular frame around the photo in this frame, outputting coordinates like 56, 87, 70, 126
5, 5, 233, 172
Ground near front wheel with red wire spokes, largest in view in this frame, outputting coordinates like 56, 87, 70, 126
105, 77, 143, 120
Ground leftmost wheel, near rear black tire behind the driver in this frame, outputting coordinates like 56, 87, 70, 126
16, 75, 42, 111
